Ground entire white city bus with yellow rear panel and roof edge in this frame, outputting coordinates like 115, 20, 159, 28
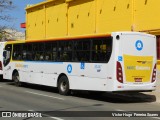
3, 32, 157, 95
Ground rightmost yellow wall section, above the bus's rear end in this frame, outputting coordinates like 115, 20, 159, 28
134, 0, 160, 34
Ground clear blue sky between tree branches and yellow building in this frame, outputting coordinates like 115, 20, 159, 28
4, 0, 45, 31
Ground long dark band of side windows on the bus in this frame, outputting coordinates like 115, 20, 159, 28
12, 37, 113, 63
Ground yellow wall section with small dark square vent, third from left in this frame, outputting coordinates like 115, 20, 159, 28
68, 0, 96, 36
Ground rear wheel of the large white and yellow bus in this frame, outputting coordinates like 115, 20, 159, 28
58, 76, 70, 95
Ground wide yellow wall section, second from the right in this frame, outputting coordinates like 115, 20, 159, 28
96, 0, 132, 33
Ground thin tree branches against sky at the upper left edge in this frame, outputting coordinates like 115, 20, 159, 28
0, 0, 14, 39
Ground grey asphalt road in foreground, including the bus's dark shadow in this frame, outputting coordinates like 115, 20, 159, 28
0, 80, 160, 120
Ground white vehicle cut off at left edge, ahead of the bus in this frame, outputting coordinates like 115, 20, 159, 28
0, 42, 5, 80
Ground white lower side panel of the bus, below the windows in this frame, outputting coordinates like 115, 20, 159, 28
10, 62, 112, 91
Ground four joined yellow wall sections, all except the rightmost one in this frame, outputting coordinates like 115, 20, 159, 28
26, 0, 133, 39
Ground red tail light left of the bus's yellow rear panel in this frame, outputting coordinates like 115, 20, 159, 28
116, 62, 123, 83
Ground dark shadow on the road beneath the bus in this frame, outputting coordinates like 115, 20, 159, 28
1, 80, 156, 103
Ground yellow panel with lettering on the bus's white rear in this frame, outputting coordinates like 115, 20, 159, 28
124, 55, 153, 83
